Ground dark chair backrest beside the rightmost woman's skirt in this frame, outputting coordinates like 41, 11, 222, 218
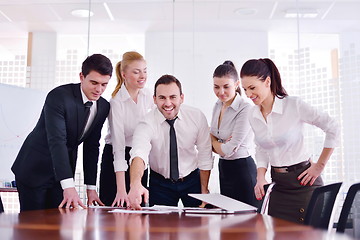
304, 182, 342, 230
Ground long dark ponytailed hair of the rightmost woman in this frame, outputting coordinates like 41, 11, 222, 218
240, 58, 288, 98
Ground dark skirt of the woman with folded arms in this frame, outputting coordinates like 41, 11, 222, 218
219, 156, 260, 207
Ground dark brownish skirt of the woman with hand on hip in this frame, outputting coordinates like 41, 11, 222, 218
268, 163, 323, 223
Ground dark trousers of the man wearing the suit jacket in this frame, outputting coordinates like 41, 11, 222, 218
16, 179, 64, 211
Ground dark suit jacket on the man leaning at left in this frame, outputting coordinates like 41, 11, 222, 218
11, 84, 110, 187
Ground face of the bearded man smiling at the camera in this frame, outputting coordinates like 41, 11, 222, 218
154, 83, 184, 119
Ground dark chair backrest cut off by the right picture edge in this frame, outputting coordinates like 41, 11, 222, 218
336, 183, 360, 238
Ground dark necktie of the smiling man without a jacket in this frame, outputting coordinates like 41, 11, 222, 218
166, 118, 179, 181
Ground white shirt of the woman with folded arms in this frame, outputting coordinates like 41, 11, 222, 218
210, 94, 254, 160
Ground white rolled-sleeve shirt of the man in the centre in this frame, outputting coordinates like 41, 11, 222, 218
130, 104, 214, 178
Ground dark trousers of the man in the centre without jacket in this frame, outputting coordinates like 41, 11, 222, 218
149, 169, 201, 207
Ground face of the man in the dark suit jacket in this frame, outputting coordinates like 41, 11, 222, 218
80, 71, 111, 101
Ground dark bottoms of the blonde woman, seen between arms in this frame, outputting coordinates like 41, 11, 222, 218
99, 144, 148, 206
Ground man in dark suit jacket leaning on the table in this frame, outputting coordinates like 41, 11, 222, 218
11, 54, 113, 211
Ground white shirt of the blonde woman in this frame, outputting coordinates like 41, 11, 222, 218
105, 85, 155, 172
